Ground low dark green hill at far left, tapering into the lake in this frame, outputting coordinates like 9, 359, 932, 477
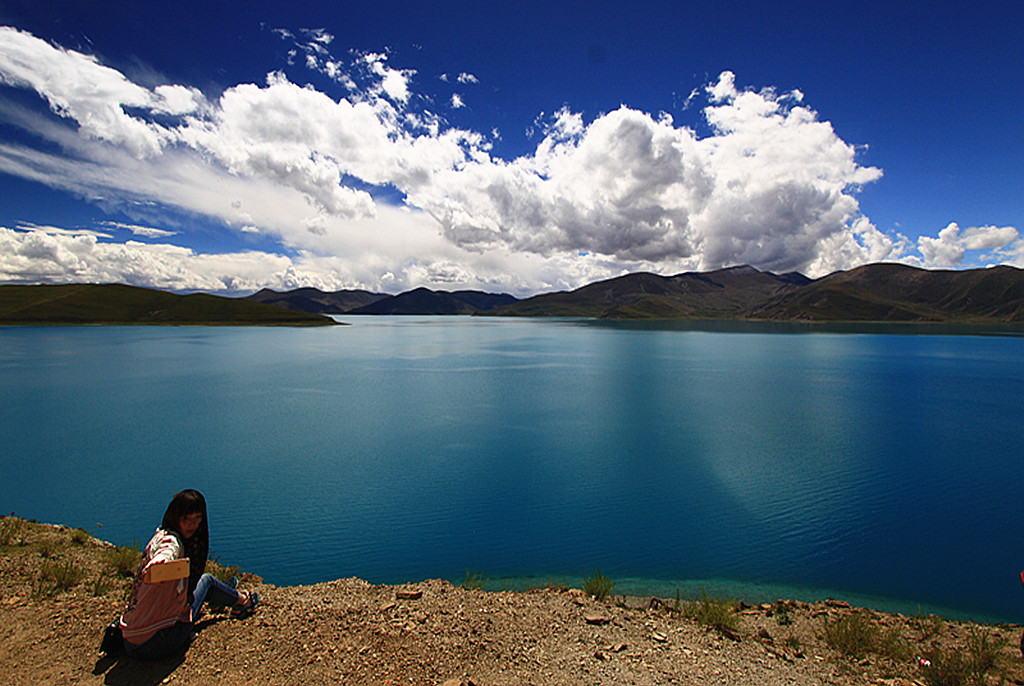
0, 284, 336, 326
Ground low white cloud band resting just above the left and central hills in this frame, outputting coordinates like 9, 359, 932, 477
0, 216, 623, 296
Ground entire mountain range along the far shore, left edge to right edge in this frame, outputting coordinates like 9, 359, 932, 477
0, 263, 1024, 325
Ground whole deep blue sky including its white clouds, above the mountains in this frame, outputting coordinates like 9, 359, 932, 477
0, 0, 1024, 296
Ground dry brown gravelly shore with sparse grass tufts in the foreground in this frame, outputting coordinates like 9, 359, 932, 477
0, 517, 1024, 686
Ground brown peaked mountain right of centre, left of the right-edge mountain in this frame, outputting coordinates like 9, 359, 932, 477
488, 266, 811, 318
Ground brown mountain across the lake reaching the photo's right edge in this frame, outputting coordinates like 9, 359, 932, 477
746, 264, 1024, 323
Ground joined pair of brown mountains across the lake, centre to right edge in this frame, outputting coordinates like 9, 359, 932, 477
486, 264, 1024, 323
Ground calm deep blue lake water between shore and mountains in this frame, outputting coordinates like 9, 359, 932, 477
0, 316, 1024, 621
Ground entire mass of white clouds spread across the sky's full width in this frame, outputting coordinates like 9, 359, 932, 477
0, 28, 1024, 295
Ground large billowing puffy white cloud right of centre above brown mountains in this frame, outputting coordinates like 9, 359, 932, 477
409, 73, 881, 278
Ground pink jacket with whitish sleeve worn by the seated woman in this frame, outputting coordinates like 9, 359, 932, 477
121, 528, 191, 645
